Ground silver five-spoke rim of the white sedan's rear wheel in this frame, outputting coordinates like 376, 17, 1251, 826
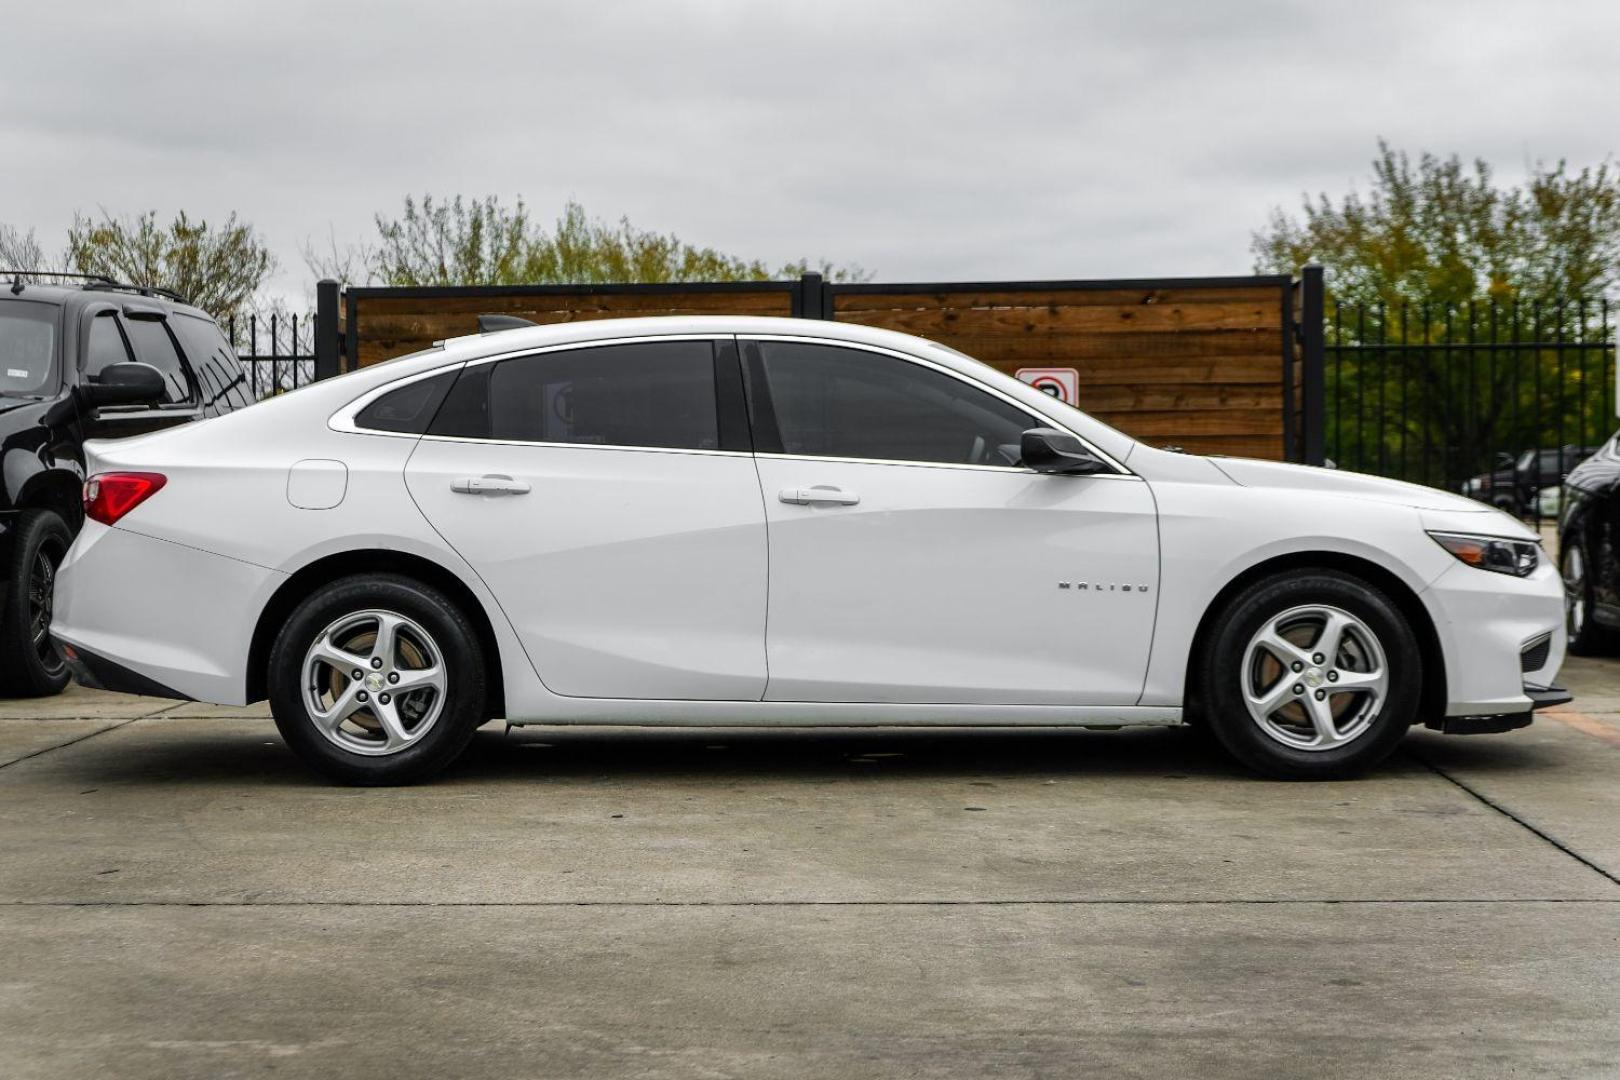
303, 609, 449, 756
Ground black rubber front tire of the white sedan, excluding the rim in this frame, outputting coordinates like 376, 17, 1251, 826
1202, 572, 1422, 779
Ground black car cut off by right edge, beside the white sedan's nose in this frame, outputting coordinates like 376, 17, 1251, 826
1558, 434, 1620, 656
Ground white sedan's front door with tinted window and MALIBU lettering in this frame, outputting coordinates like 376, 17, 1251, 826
744, 340, 1158, 704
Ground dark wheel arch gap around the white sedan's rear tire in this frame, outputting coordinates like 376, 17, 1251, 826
246, 549, 505, 717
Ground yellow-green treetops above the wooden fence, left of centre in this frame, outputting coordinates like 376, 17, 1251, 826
345, 196, 865, 285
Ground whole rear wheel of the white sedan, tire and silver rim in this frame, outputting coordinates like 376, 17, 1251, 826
267, 573, 488, 785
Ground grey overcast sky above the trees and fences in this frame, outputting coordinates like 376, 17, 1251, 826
0, 0, 1620, 298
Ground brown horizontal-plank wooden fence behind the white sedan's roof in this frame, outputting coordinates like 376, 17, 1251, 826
345, 277, 1302, 460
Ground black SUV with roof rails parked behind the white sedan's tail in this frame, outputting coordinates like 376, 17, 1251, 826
0, 270, 253, 696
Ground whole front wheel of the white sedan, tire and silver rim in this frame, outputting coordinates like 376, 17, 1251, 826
1199, 570, 1422, 780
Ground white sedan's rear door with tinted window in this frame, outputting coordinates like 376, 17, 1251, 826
407, 337, 766, 701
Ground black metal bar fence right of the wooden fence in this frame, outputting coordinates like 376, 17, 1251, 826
1324, 300, 1620, 517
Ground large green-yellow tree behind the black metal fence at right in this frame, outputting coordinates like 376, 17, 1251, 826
1252, 141, 1620, 486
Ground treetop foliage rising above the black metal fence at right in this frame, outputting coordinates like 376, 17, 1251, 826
1251, 139, 1620, 308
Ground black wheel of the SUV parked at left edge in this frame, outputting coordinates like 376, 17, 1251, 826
0, 510, 73, 698
